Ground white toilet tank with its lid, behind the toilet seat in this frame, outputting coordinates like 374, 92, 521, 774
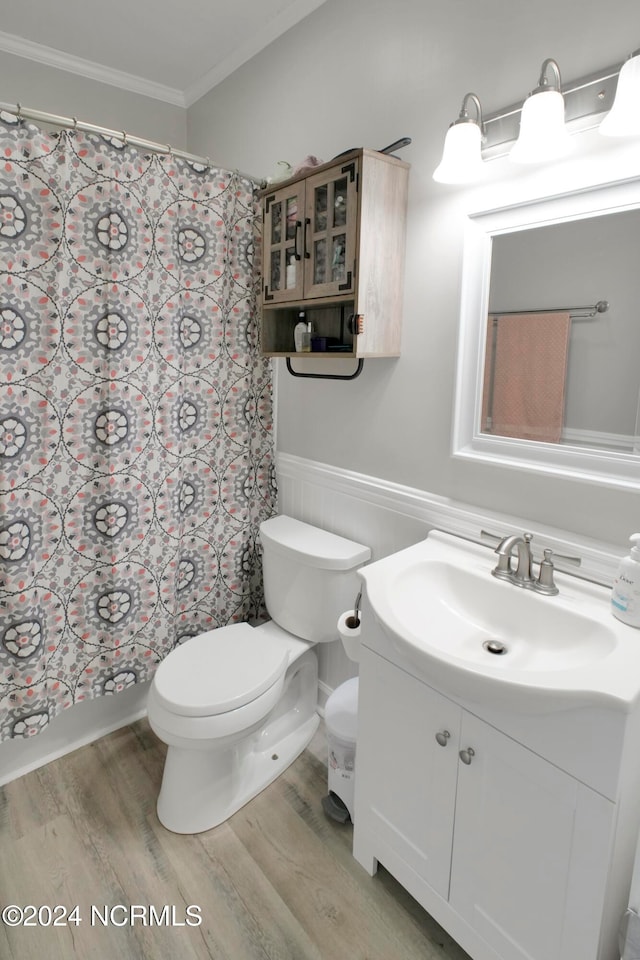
260, 516, 371, 643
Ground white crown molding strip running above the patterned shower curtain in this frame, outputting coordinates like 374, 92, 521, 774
0, 31, 187, 108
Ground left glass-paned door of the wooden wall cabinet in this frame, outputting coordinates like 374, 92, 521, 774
263, 184, 304, 303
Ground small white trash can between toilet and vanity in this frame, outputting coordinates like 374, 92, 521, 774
322, 677, 358, 823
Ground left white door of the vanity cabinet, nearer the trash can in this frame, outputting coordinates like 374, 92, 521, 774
354, 647, 461, 899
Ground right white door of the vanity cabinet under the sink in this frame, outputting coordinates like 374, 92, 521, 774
450, 713, 614, 960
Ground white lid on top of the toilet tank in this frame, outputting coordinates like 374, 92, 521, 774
260, 514, 371, 570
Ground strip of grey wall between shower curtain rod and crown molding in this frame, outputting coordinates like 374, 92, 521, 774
0, 50, 187, 150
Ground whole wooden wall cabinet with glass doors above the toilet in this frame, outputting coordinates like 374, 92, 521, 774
261, 149, 409, 358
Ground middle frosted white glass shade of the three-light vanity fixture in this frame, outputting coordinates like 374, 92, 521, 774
509, 90, 571, 163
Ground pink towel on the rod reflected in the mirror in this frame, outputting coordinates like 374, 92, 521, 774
482, 313, 571, 443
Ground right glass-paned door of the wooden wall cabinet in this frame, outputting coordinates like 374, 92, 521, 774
304, 161, 358, 297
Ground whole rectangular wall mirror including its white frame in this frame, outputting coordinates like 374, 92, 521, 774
453, 180, 640, 487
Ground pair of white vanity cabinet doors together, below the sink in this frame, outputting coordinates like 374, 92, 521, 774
353, 648, 620, 960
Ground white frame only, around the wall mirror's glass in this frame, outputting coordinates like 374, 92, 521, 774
452, 178, 640, 490
